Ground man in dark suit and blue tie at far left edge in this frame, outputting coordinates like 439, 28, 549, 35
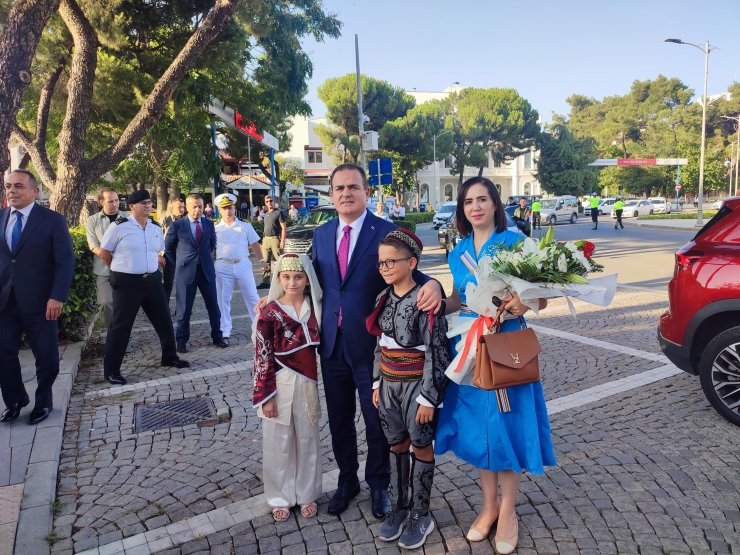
0, 170, 75, 424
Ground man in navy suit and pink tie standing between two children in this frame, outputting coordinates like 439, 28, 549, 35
312, 164, 442, 518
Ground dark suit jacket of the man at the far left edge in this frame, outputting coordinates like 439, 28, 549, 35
0, 204, 75, 314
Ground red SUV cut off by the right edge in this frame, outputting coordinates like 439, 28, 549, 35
658, 197, 740, 426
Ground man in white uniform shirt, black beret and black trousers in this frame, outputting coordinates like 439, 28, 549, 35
100, 190, 190, 385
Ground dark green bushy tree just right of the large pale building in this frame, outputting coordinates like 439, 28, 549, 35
536, 124, 597, 196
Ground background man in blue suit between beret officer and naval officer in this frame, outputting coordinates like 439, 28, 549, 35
165, 193, 229, 353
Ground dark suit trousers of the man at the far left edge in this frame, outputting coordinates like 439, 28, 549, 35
0, 289, 58, 408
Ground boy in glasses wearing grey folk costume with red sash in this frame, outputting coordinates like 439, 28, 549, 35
367, 228, 450, 549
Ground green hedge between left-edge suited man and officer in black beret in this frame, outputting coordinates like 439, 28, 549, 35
59, 226, 98, 341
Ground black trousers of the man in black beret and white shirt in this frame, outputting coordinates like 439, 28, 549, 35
103, 271, 177, 376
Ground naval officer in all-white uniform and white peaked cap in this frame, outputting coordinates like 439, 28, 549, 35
215, 193, 270, 342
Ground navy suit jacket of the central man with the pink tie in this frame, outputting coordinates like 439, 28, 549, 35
311, 211, 429, 364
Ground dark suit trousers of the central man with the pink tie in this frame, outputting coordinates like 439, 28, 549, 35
321, 330, 390, 489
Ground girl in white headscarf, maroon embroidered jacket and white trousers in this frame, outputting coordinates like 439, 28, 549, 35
253, 254, 321, 522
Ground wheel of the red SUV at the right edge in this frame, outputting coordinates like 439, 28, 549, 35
699, 326, 740, 426
